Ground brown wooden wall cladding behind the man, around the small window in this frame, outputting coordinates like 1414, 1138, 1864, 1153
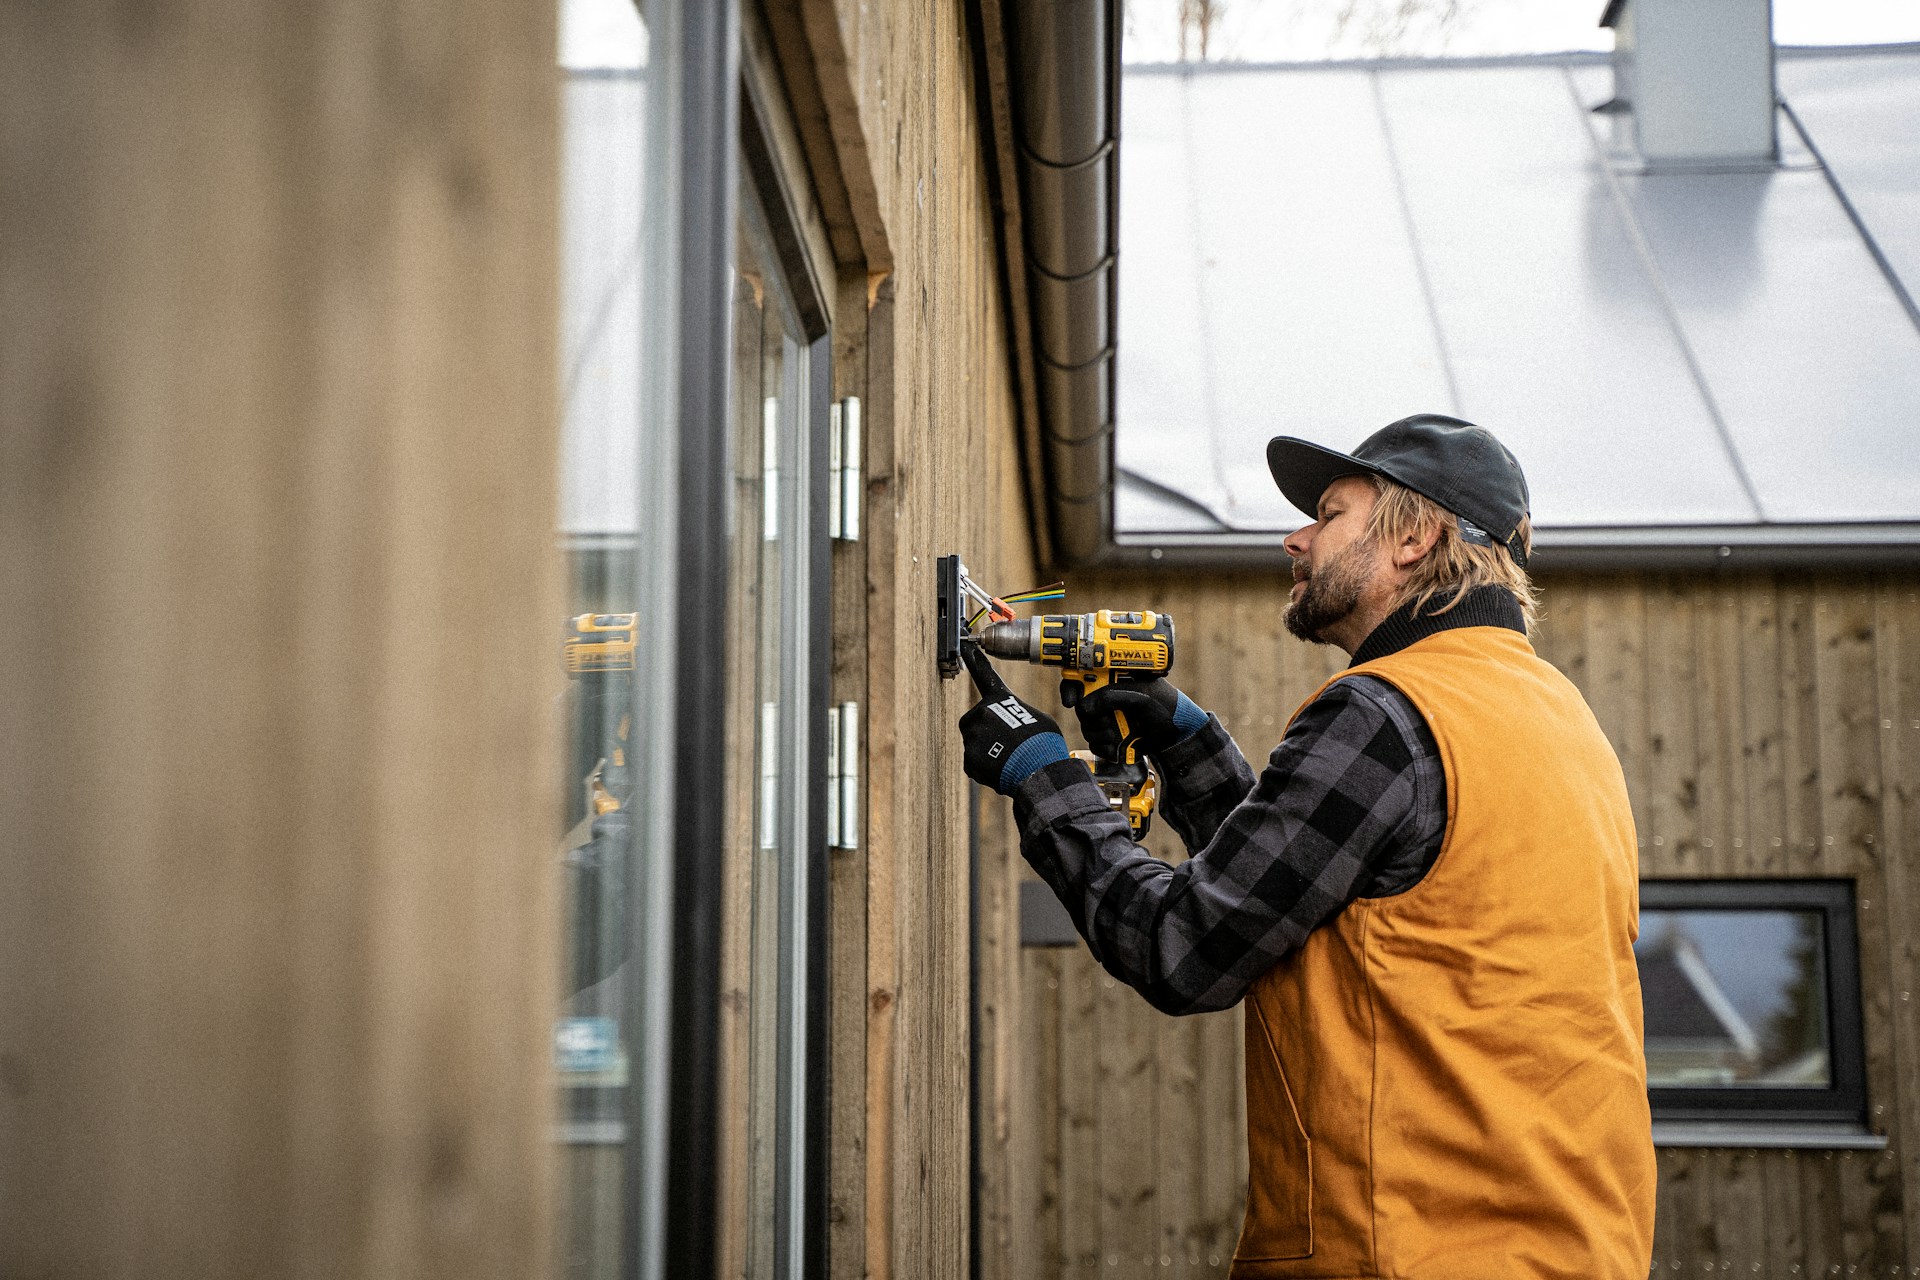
1010, 574, 1920, 1276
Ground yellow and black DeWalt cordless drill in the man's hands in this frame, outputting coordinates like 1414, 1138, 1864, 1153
973, 608, 1173, 841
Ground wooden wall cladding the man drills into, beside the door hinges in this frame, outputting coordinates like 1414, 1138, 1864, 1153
756, 0, 1046, 1280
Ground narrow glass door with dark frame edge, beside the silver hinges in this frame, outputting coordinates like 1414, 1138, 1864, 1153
722, 147, 828, 1278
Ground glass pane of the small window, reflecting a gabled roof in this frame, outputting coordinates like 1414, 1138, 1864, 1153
1634, 910, 1834, 1088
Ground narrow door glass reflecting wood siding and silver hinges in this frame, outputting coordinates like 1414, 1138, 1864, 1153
722, 186, 818, 1276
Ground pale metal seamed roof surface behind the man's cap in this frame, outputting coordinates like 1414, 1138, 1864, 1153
1116, 46, 1920, 547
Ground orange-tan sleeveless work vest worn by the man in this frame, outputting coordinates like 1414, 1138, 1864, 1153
1231, 628, 1655, 1280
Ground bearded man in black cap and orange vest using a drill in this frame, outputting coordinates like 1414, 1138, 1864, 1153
960, 415, 1655, 1280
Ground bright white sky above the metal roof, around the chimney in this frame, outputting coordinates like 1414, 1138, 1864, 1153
1123, 0, 1920, 63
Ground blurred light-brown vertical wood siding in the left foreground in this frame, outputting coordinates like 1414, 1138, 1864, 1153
0, 0, 564, 1280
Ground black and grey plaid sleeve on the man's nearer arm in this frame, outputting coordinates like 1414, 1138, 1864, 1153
1014, 677, 1446, 1013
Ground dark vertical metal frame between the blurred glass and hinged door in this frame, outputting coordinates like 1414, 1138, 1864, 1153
637, 0, 739, 1280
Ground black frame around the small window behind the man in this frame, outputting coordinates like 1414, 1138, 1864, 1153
1640, 879, 1866, 1128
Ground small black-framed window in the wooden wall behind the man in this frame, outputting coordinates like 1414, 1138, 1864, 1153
1634, 881, 1866, 1146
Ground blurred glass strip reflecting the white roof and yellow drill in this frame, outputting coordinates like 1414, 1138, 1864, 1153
553, 0, 649, 1280
